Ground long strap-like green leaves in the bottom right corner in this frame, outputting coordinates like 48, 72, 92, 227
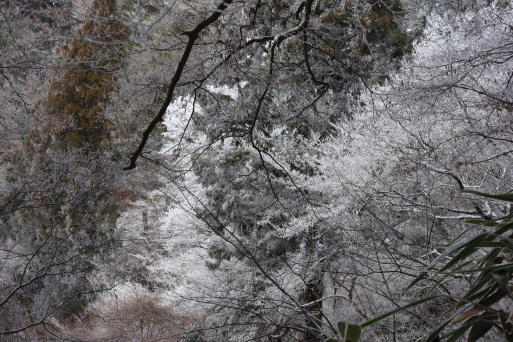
338, 191, 513, 342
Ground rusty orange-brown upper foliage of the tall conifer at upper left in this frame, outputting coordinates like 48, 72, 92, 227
43, 0, 127, 151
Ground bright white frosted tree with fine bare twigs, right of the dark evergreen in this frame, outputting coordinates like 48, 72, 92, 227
326, 2, 512, 341
